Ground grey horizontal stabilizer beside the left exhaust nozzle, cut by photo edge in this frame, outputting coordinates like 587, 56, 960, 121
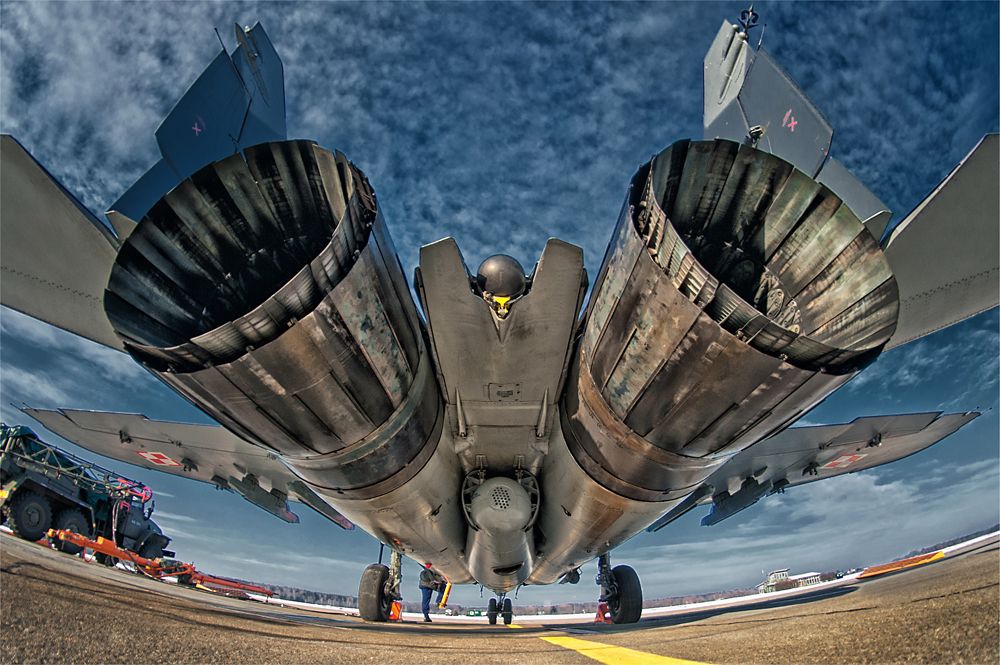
0, 134, 122, 351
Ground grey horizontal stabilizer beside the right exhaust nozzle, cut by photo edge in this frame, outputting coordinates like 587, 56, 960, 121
883, 134, 1000, 349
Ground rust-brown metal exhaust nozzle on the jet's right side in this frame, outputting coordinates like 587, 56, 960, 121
562, 140, 899, 502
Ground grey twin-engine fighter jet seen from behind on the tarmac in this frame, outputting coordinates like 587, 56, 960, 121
0, 8, 1000, 623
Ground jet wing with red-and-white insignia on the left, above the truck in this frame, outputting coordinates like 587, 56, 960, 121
23, 409, 354, 529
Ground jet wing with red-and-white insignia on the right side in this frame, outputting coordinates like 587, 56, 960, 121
647, 412, 980, 532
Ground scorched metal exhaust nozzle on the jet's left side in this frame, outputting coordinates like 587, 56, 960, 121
105, 141, 442, 498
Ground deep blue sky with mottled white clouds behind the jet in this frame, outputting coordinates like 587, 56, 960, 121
0, 0, 1000, 604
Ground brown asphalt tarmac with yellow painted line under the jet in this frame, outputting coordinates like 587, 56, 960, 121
0, 534, 1000, 664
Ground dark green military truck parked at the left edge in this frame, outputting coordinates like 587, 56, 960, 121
0, 423, 174, 563
